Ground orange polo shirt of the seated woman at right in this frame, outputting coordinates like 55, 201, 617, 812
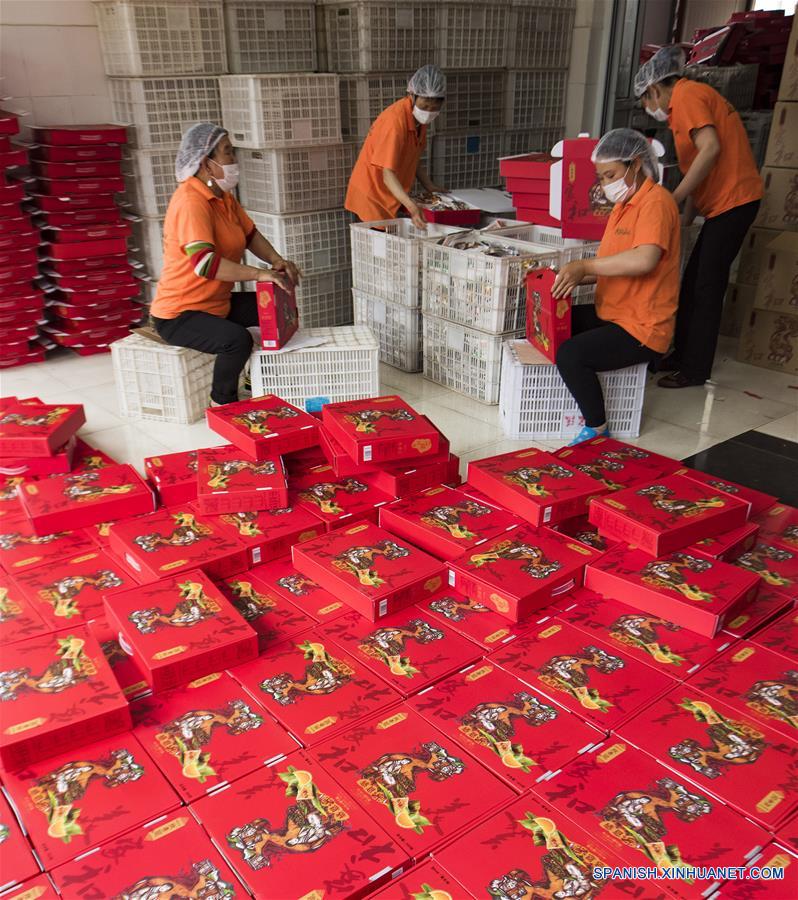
596, 178, 680, 353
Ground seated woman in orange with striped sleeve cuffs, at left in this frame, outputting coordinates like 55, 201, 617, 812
150, 122, 300, 406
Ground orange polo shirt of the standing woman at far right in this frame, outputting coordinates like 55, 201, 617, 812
668, 78, 763, 218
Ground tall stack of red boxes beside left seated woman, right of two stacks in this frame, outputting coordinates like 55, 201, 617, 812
30, 125, 142, 356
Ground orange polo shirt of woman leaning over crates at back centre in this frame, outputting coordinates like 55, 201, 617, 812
344, 97, 427, 222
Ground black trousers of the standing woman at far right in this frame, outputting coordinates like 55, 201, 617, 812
673, 200, 759, 381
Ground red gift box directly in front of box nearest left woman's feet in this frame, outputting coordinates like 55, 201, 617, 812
197, 446, 288, 516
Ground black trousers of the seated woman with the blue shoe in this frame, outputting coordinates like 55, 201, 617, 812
557, 305, 662, 428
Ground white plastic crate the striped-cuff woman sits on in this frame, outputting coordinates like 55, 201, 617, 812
111, 334, 216, 425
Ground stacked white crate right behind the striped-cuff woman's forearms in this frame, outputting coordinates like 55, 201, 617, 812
247, 209, 352, 275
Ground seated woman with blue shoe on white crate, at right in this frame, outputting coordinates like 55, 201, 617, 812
552, 128, 680, 444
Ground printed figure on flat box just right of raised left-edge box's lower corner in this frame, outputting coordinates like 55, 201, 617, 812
155, 699, 263, 784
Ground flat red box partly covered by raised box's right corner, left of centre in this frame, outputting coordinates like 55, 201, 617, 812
218, 569, 317, 653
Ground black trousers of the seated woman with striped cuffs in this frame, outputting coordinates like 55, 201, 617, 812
152, 291, 258, 403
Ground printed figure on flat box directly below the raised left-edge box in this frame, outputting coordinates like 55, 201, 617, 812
28, 747, 145, 844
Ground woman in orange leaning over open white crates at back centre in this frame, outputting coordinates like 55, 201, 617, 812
344, 65, 446, 228
